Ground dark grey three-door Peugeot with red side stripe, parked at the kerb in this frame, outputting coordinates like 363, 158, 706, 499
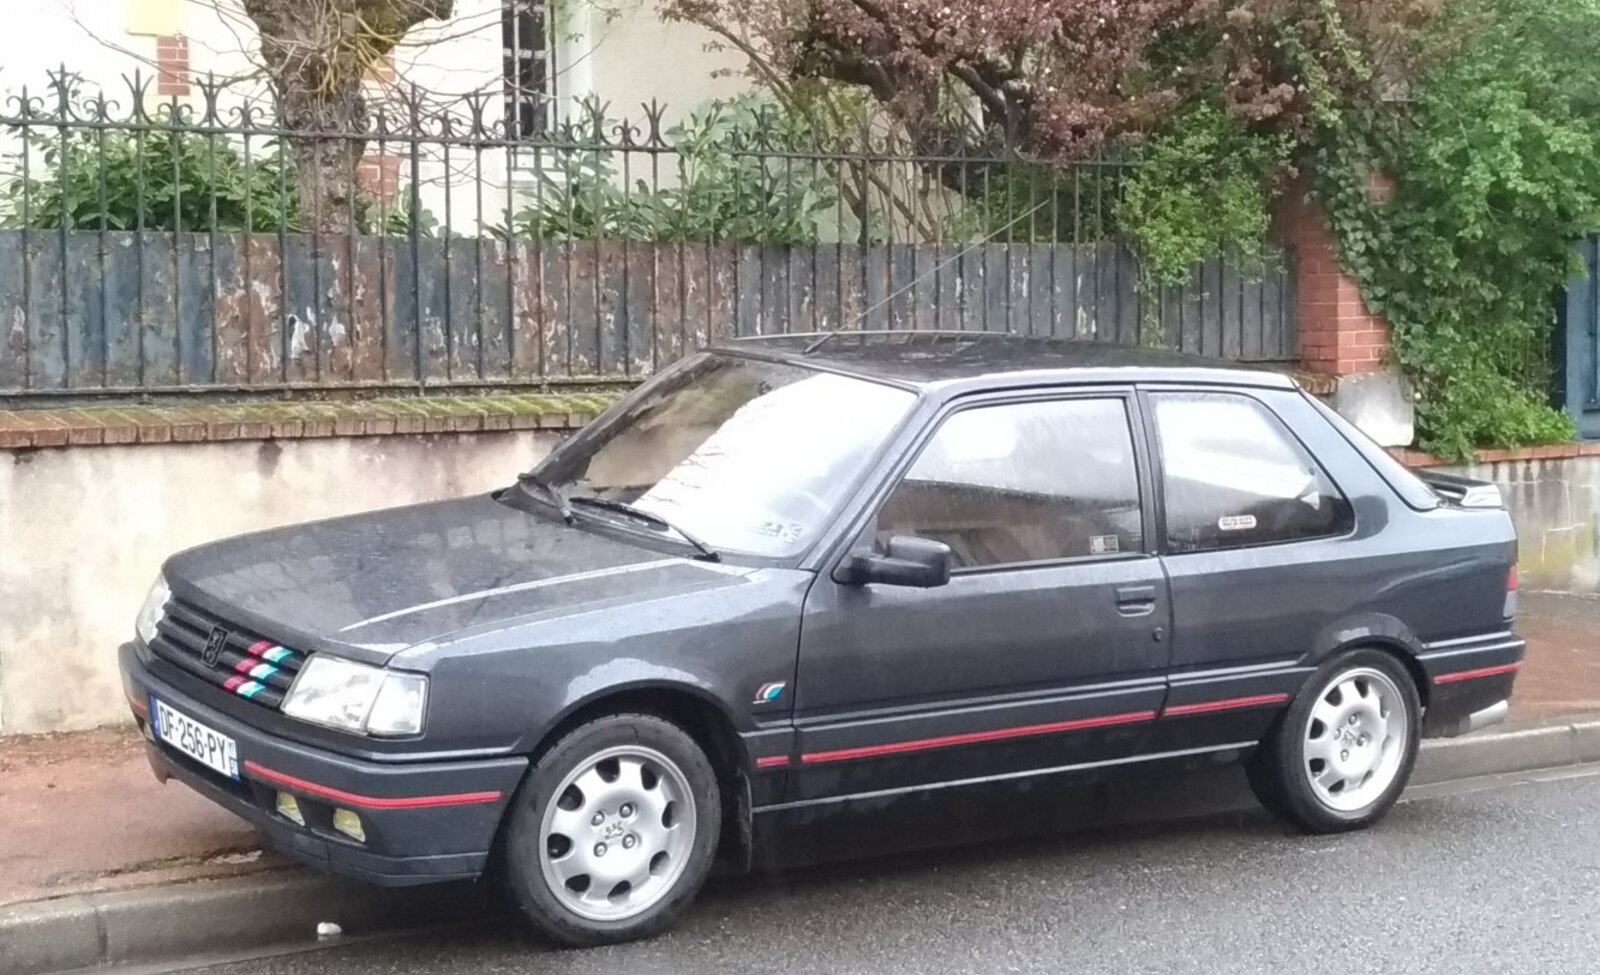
122, 333, 1523, 945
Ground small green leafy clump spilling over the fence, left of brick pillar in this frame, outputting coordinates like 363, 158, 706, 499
1117, 102, 1291, 285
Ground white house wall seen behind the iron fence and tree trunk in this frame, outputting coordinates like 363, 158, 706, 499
0, 0, 747, 234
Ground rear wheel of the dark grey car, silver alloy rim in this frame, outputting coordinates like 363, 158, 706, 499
1248, 650, 1422, 833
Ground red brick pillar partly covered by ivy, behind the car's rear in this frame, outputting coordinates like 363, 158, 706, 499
1278, 178, 1389, 376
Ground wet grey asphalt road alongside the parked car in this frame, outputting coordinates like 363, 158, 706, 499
172, 768, 1600, 975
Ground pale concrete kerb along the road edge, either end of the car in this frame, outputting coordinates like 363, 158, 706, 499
0, 717, 1600, 975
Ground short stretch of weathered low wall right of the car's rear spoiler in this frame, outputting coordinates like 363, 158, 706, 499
1446, 456, 1600, 592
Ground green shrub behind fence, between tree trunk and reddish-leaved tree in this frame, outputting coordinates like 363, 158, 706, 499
499, 96, 838, 243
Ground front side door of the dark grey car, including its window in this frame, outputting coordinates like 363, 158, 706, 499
789, 389, 1170, 802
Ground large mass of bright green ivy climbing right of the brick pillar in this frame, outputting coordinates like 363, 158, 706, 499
1317, 0, 1600, 458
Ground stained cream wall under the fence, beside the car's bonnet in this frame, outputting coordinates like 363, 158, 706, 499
0, 431, 555, 733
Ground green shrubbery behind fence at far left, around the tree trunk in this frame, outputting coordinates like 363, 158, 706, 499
0, 112, 438, 237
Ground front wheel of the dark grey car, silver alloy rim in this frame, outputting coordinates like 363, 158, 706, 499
501, 714, 722, 948
